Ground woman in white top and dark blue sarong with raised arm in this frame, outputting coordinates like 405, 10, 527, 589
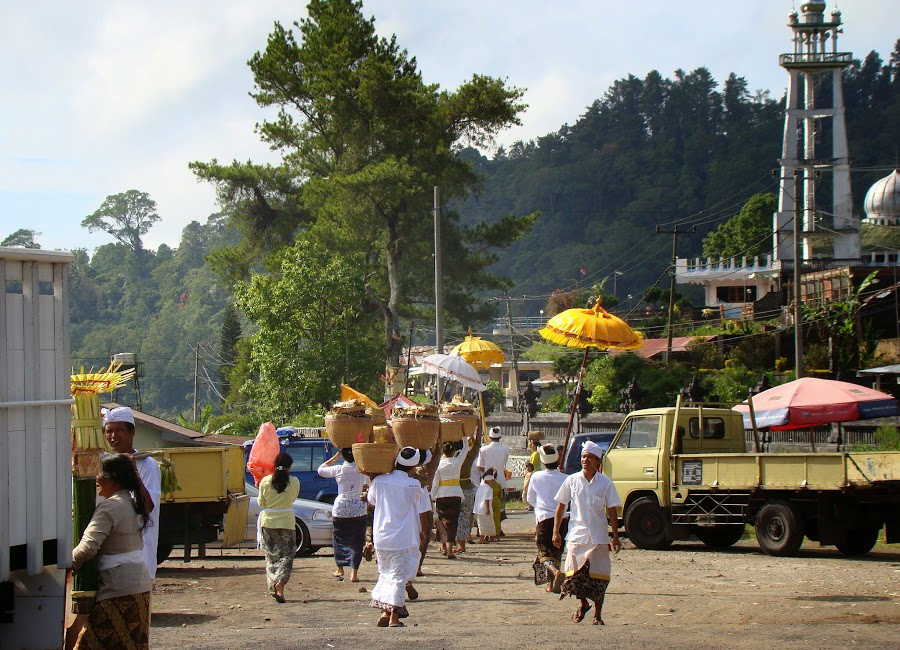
318, 447, 369, 582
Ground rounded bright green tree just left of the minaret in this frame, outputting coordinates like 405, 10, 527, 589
703, 192, 778, 259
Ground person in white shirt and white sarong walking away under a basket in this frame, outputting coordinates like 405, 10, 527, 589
367, 447, 431, 627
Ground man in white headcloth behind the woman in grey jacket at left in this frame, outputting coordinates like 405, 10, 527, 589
103, 406, 161, 580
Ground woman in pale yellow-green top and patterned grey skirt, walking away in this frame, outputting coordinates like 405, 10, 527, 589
256, 451, 300, 603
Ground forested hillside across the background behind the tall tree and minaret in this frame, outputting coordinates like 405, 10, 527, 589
11, 42, 900, 417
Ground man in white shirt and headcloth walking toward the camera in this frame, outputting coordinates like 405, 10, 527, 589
553, 440, 622, 625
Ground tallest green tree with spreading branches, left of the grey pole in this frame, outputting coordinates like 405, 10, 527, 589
191, 0, 535, 366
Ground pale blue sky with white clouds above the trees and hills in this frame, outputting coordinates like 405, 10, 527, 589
0, 0, 900, 251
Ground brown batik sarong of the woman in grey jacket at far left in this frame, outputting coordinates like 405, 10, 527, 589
75, 591, 150, 650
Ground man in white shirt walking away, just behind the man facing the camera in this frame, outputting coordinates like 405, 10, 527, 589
525, 445, 569, 594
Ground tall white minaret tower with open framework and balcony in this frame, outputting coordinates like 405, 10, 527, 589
774, 0, 860, 260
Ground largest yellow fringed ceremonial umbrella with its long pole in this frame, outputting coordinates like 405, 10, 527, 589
540, 300, 644, 462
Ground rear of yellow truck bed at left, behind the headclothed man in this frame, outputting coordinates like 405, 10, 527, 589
146, 445, 249, 562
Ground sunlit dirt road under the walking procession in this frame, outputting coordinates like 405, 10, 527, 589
151, 511, 900, 650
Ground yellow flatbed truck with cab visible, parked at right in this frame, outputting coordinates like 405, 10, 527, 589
603, 400, 900, 556
